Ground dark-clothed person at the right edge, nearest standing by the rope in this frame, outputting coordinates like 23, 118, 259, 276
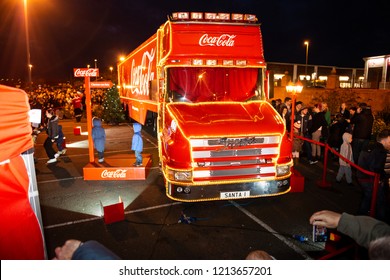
352, 129, 390, 222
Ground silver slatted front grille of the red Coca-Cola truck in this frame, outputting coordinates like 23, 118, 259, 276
190, 136, 280, 181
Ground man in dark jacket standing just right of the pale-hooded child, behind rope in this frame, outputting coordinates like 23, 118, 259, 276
351, 103, 374, 162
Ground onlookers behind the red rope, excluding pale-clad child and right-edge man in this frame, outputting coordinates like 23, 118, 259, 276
272, 97, 374, 164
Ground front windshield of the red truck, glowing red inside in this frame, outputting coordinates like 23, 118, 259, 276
167, 67, 262, 102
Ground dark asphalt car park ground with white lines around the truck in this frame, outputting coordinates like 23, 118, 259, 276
34, 119, 361, 260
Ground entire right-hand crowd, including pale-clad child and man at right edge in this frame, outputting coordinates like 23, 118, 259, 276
272, 97, 390, 222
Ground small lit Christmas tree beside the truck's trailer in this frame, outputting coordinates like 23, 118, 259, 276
102, 85, 125, 124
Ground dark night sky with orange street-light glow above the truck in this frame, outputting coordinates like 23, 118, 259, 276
0, 0, 390, 81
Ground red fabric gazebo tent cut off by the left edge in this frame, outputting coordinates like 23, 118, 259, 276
0, 85, 45, 260
